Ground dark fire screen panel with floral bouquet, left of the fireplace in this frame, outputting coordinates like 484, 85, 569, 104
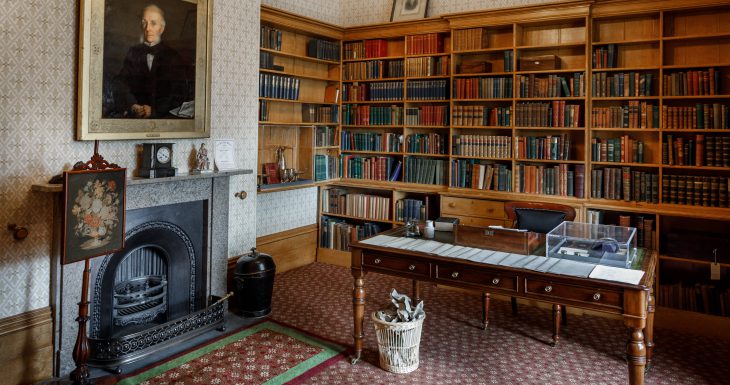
61, 168, 127, 265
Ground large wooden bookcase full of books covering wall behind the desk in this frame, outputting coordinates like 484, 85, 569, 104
256, 0, 730, 327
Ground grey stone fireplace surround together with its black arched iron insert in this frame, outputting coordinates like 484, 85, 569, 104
51, 170, 251, 376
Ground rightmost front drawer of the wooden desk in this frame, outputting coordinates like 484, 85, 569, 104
525, 278, 623, 309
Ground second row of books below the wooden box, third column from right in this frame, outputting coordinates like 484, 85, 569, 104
515, 100, 581, 127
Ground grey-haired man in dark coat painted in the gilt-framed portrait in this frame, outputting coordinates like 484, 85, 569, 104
103, 5, 195, 119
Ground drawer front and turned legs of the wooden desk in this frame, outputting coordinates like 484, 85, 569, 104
351, 229, 657, 385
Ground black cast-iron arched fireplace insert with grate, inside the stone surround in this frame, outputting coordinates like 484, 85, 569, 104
89, 201, 208, 366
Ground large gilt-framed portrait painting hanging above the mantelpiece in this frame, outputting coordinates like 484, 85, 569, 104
76, 0, 212, 140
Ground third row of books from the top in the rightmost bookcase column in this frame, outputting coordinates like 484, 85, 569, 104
662, 134, 730, 167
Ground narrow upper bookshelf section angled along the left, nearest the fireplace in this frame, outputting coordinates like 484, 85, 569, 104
258, 6, 342, 192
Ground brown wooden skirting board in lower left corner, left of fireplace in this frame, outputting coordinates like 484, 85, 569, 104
0, 307, 53, 385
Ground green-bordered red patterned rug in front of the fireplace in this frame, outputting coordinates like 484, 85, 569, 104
117, 321, 345, 385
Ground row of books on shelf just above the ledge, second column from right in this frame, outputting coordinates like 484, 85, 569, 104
591, 167, 659, 203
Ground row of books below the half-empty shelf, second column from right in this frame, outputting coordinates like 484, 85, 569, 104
591, 72, 655, 98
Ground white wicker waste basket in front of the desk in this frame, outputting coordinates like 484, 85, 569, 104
371, 313, 426, 373
